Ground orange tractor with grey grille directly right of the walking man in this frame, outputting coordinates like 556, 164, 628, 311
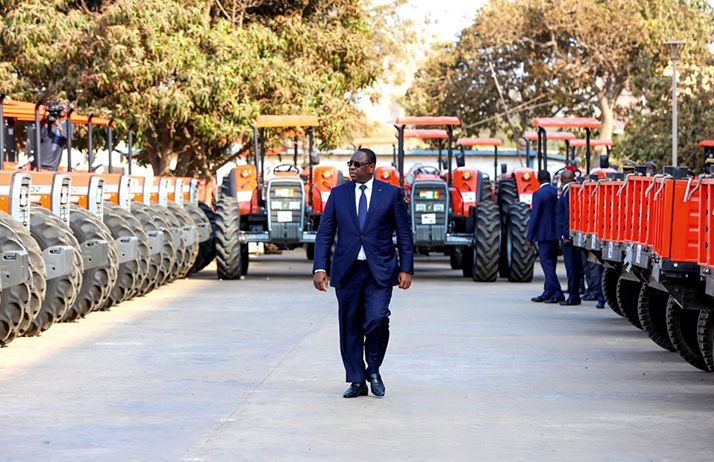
396, 117, 499, 281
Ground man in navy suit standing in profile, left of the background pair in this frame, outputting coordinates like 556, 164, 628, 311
526, 170, 565, 303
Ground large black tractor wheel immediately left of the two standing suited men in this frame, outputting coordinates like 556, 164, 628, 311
499, 202, 536, 282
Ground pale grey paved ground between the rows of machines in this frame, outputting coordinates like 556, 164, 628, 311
0, 251, 714, 462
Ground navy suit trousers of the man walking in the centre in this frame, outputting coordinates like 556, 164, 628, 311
335, 260, 392, 382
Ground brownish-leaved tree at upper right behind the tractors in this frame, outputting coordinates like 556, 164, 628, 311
407, 0, 711, 152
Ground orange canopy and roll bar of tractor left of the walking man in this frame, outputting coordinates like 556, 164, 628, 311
250, 115, 319, 212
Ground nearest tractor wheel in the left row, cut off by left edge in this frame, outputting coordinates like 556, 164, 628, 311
0, 213, 32, 345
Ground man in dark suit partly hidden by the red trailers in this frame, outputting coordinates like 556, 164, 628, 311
555, 167, 582, 305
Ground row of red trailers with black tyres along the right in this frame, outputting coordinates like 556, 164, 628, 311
570, 148, 714, 372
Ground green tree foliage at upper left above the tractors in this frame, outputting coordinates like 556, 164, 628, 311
0, 0, 394, 174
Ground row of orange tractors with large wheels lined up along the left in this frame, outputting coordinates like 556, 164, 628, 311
0, 98, 215, 345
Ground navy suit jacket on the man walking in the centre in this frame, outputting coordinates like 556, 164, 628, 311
313, 180, 414, 288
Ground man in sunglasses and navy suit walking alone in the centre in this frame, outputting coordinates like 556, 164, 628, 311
313, 148, 414, 398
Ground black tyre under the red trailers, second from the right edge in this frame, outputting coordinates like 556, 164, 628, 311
667, 297, 714, 372
